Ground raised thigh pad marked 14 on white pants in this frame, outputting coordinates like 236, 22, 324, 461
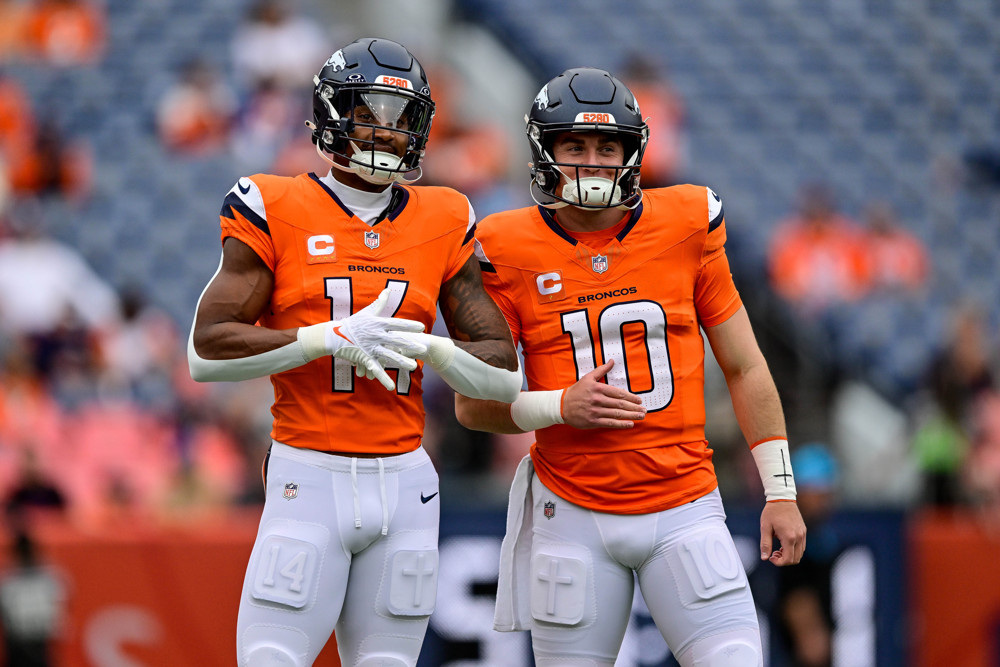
250, 519, 330, 610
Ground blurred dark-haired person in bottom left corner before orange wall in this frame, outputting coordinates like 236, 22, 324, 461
0, 531, 67, 667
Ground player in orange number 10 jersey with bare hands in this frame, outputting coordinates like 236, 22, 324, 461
450, 68, 805, 667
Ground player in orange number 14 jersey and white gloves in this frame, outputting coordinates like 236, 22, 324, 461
188, 39, 521, 667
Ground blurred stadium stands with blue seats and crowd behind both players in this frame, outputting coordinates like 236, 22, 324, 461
0, 0, 1000, 667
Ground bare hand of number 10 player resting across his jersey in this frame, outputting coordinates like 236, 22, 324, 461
562, 359, 646, 428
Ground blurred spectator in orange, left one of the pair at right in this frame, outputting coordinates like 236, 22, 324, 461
768, 184, 868, 314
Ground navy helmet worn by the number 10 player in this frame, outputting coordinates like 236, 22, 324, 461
525, 67, 649, 209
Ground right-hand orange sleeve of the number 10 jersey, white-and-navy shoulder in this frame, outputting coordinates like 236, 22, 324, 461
694, 198, 743, 327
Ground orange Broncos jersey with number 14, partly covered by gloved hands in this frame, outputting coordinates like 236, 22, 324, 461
220, 174, 474, 454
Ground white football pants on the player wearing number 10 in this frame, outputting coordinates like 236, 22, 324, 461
530, 476, 762, 667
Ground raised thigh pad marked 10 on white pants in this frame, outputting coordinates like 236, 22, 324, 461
666, 525, 747, 609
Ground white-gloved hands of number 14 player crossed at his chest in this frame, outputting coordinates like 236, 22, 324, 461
325, 289, 426, 390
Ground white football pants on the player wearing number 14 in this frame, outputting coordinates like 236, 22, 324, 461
237, 442, 440, 667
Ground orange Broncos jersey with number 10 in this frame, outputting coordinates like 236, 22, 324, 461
476, 185, 742, 514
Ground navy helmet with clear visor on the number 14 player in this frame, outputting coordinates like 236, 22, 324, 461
306, 37, 434, 184
